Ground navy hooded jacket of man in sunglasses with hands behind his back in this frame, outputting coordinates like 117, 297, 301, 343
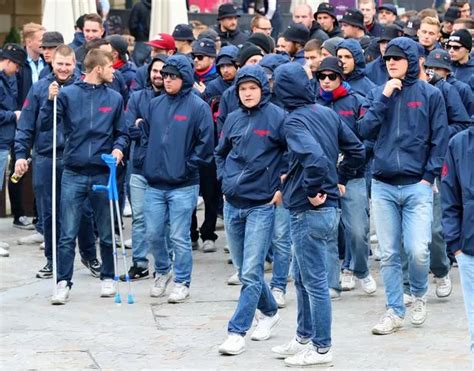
142, 55, 214, 190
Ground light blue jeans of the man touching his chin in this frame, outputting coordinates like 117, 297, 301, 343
372, 179, 433, 317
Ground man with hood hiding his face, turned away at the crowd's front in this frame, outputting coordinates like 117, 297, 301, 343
272, 63, 365, 367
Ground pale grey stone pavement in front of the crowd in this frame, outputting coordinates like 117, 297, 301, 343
0, 217, 470, 370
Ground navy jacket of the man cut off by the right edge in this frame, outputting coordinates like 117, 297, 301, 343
441, 126, 474, 256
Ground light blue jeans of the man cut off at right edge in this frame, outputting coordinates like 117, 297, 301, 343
456, 253, 474, 369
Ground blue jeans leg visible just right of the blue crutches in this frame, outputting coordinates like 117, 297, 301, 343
129, 174, 149, 268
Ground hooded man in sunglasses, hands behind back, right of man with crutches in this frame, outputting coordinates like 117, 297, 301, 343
141, 55, 214, 303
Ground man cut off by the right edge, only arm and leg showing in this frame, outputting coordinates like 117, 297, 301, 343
441, 126, 474, 367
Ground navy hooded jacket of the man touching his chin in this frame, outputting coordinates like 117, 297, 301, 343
357, 37, 449, 185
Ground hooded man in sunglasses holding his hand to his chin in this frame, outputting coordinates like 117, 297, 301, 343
358, 37, 449, 335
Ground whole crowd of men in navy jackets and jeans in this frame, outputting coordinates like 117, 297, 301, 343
0, 0, 474, 367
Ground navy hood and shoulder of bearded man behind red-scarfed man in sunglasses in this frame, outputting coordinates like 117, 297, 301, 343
337, 39, 376, 97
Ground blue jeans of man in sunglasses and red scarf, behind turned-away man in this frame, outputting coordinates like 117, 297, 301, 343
341, 178, 370, 278
